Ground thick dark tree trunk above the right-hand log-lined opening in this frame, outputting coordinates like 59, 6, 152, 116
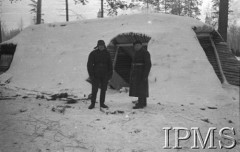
218, 0, 229, 41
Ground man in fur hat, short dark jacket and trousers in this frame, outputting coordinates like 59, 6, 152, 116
87, 40, 113, 109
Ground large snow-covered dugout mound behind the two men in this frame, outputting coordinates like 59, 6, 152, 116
0, 14, 236, 100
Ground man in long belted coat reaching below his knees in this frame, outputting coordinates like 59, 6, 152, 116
129, 41, 152, 109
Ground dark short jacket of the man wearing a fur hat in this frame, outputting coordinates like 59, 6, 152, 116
87, 49, 113, 80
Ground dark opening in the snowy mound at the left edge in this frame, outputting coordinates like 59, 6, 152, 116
0, 43, 17, 74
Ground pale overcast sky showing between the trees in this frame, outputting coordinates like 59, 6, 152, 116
1, 0, 240, 30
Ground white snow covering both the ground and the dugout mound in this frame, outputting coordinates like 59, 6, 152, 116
0, 14, 240, 152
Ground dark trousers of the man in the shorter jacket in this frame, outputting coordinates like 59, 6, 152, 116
91, 77, 108, 105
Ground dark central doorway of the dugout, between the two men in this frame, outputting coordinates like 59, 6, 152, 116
107, 32, 151, 89
